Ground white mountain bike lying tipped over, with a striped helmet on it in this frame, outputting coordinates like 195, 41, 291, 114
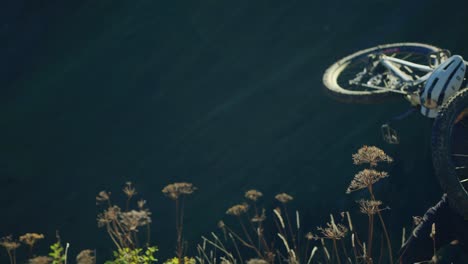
323, 43, 468, 219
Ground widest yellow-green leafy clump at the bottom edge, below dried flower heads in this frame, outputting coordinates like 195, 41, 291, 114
105, 247, 158, 264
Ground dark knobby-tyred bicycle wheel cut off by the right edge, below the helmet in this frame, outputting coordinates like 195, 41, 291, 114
432, 88, 468, 220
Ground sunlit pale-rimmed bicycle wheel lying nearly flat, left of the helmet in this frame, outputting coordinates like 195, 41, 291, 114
323, 43, 441, 103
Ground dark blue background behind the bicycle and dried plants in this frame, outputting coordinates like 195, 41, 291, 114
0, 0, 468, 263
